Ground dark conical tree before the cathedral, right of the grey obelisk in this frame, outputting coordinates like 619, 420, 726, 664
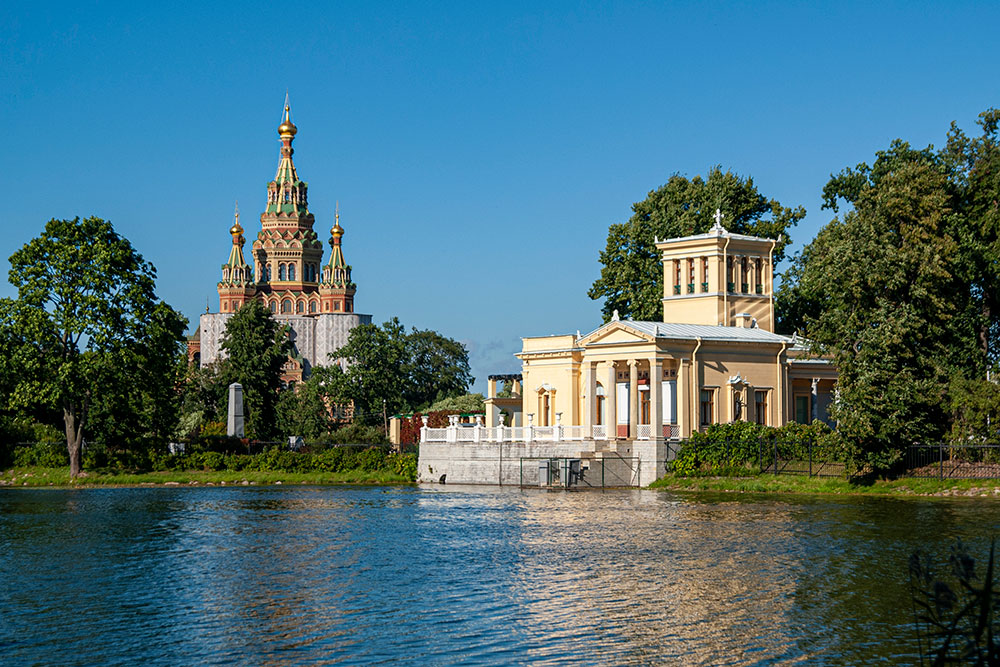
220, 299, 291, 439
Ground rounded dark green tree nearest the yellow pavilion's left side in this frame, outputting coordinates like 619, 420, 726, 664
403, 329, 474, 410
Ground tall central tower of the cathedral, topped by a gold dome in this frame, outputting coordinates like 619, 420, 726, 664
247, 96, 323, 315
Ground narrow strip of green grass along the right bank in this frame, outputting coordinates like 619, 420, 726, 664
649, 474, 1000, 497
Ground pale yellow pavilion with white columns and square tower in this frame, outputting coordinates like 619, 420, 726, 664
498, 214, 837, 440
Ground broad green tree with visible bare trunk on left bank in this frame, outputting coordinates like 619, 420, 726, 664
4, 218, 184, 477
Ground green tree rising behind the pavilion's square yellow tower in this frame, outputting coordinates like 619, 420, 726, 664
588, 166, 805, 321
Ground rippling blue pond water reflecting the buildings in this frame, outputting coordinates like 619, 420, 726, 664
0, 486, 1000, 665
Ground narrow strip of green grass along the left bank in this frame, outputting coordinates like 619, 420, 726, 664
0, 467, 412, 488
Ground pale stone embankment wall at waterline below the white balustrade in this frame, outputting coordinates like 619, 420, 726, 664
417, 441, 669, 488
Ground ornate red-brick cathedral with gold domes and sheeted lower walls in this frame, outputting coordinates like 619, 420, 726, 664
188, 98, 371, 384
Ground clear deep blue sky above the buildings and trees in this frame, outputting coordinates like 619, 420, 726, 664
0, 2, 1000, 390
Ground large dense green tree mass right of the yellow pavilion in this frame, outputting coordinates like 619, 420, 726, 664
777, 110, 1000, 469
